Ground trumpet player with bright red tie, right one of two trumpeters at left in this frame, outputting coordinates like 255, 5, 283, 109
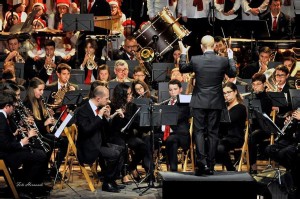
80, 39, 105, 84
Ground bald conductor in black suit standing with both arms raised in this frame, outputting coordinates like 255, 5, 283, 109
179, 35, 236, 175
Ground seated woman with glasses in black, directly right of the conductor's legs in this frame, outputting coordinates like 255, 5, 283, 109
217, 82, 247, 171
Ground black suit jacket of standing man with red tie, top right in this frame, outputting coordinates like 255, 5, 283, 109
260, 12, 292, 39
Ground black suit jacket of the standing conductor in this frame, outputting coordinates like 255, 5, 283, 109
179, 52, 236, 109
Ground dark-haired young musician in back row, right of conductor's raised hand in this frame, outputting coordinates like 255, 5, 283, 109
239, 46, 272, 79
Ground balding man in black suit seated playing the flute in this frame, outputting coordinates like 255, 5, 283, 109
76, 86, 122, 192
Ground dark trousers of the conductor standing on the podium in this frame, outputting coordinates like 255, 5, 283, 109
193, 108, 221, 170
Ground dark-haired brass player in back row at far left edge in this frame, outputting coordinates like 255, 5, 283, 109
2, 35, 27, 63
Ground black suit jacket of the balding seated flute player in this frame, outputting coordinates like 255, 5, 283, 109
75, 103, 108, 164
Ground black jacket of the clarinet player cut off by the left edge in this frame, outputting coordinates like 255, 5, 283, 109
0, 112, 23, 159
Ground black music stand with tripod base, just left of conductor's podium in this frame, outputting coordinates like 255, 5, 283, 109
138, 104, 178, 196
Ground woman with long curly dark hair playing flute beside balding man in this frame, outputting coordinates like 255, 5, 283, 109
109, 83, 151, 183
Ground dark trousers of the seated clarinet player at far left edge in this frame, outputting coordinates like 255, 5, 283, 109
5, 146, 47, 184
